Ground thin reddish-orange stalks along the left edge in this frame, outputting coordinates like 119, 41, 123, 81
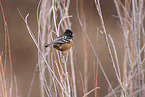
0, 1, 15, 97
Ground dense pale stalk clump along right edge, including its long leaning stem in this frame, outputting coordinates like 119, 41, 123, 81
95, 0, 144, 97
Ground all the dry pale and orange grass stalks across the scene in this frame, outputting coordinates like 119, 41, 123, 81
0, 0, 145, 97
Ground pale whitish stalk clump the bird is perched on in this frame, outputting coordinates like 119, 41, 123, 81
24, 0, 77, 97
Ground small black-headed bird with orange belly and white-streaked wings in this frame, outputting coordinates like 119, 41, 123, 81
45, 29, 74, 51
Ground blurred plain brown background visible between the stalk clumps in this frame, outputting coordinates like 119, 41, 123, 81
0, 0, 123, 97
